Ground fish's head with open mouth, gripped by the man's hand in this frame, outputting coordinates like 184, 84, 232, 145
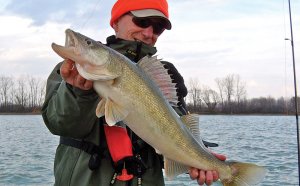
52, 29, 119, 80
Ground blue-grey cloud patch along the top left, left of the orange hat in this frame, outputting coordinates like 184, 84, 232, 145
4, 0, 113, 27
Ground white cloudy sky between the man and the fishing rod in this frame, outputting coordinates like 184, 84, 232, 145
159, 1, 299, 97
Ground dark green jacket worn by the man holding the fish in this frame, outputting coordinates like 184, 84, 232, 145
42, 36, 170, 186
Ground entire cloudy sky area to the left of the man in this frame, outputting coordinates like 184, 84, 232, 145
0, 0, 116, 78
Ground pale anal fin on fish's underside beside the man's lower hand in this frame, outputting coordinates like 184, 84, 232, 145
164, 158, 189, 180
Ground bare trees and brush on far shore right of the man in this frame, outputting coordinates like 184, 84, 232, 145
186, 74, 300, 114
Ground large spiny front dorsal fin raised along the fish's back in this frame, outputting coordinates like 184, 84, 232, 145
138, 56, 178, 107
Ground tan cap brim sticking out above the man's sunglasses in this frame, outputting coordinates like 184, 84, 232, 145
130, 9, 172, 30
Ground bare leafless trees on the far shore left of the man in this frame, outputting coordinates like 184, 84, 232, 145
0, 75, 46, 113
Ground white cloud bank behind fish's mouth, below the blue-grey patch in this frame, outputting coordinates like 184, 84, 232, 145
0, 12, 112, 78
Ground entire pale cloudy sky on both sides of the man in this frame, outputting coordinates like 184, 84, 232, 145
0, 0, 300, 98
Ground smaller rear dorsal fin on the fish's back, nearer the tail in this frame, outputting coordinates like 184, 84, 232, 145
180, 114, 202, 142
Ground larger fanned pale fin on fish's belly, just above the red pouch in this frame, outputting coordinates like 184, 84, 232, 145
100, 99, 129, 126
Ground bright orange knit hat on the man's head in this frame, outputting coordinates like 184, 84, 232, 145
110, 0, 169, 26
